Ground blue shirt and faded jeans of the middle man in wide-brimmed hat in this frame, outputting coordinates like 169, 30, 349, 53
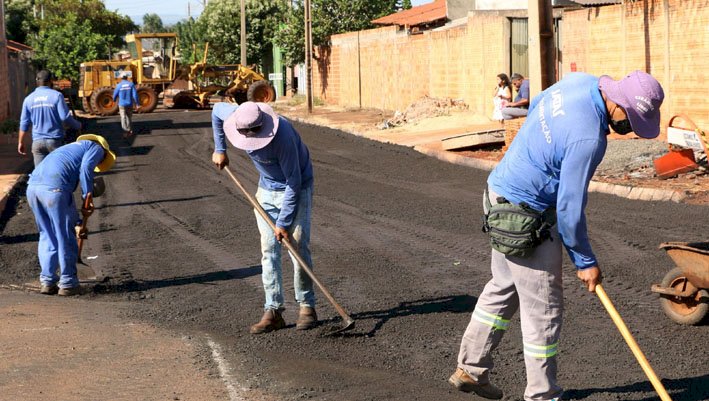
212, 103, 315, 310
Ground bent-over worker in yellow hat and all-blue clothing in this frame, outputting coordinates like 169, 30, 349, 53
27, 134, 116, 296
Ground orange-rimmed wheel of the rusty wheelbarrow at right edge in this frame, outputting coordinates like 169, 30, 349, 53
660, 267, 709, 325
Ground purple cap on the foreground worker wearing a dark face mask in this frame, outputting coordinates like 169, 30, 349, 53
598, 71, 665, 139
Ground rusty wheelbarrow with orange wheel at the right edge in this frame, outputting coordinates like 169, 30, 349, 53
651, 242, 709, 325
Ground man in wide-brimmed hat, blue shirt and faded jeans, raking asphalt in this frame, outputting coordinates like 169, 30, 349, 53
212, 102, 317, 334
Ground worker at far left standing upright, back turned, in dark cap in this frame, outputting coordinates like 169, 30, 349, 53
17, 70, 81, 167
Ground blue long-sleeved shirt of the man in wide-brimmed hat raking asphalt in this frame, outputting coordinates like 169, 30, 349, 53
212, 103, 313, 229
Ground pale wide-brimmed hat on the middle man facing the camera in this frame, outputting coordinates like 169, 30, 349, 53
224, 102, 278, 150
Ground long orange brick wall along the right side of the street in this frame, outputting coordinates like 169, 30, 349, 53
314, 0, 709, 130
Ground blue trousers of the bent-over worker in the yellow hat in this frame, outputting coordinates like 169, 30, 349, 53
27, 185, 79, 288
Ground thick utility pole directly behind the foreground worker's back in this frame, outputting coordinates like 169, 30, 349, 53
528, 0, 556, 97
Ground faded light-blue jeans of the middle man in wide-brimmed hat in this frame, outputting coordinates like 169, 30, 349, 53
254, 187, 315, 310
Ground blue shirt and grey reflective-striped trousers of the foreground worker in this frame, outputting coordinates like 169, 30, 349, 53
458, 73, 608, 401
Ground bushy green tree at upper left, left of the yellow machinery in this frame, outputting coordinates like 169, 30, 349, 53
30, 14, 110, 81
